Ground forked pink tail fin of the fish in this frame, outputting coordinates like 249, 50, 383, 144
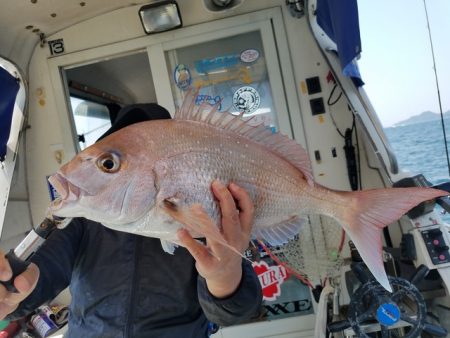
338, 187, 448, 292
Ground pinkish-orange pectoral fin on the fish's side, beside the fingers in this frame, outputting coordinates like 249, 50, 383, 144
163, 200, 245, 258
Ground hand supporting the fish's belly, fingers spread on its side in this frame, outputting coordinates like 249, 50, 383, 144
178, 180, 254, 298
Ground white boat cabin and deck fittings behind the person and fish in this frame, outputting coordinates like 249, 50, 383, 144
0, 0, 450, 338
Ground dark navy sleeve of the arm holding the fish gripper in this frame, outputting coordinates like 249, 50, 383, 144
6, 219, 84, 320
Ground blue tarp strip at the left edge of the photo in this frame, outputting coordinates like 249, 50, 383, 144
0, 67, 19, 162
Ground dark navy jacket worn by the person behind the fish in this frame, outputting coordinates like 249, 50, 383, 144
10, 218, 262, 338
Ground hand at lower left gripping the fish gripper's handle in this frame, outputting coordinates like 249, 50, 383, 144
0, 250, 39, 319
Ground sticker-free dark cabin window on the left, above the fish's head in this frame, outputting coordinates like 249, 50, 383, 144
63, 50, 156, 150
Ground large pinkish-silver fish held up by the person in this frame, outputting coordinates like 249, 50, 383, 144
49, 94, 447, 290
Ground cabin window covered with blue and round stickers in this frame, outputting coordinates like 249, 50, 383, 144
165, 31, 278, 130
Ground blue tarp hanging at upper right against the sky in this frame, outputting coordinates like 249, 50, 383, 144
317, 0, 364, 86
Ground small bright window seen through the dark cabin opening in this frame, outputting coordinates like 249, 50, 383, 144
70, 96, 111, 150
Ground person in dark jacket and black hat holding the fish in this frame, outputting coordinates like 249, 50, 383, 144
0, 105, 262, 338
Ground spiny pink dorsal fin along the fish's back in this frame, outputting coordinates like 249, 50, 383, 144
174, 90, 313, 186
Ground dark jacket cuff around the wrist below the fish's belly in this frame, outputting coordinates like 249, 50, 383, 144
197, 260, 262, 326
